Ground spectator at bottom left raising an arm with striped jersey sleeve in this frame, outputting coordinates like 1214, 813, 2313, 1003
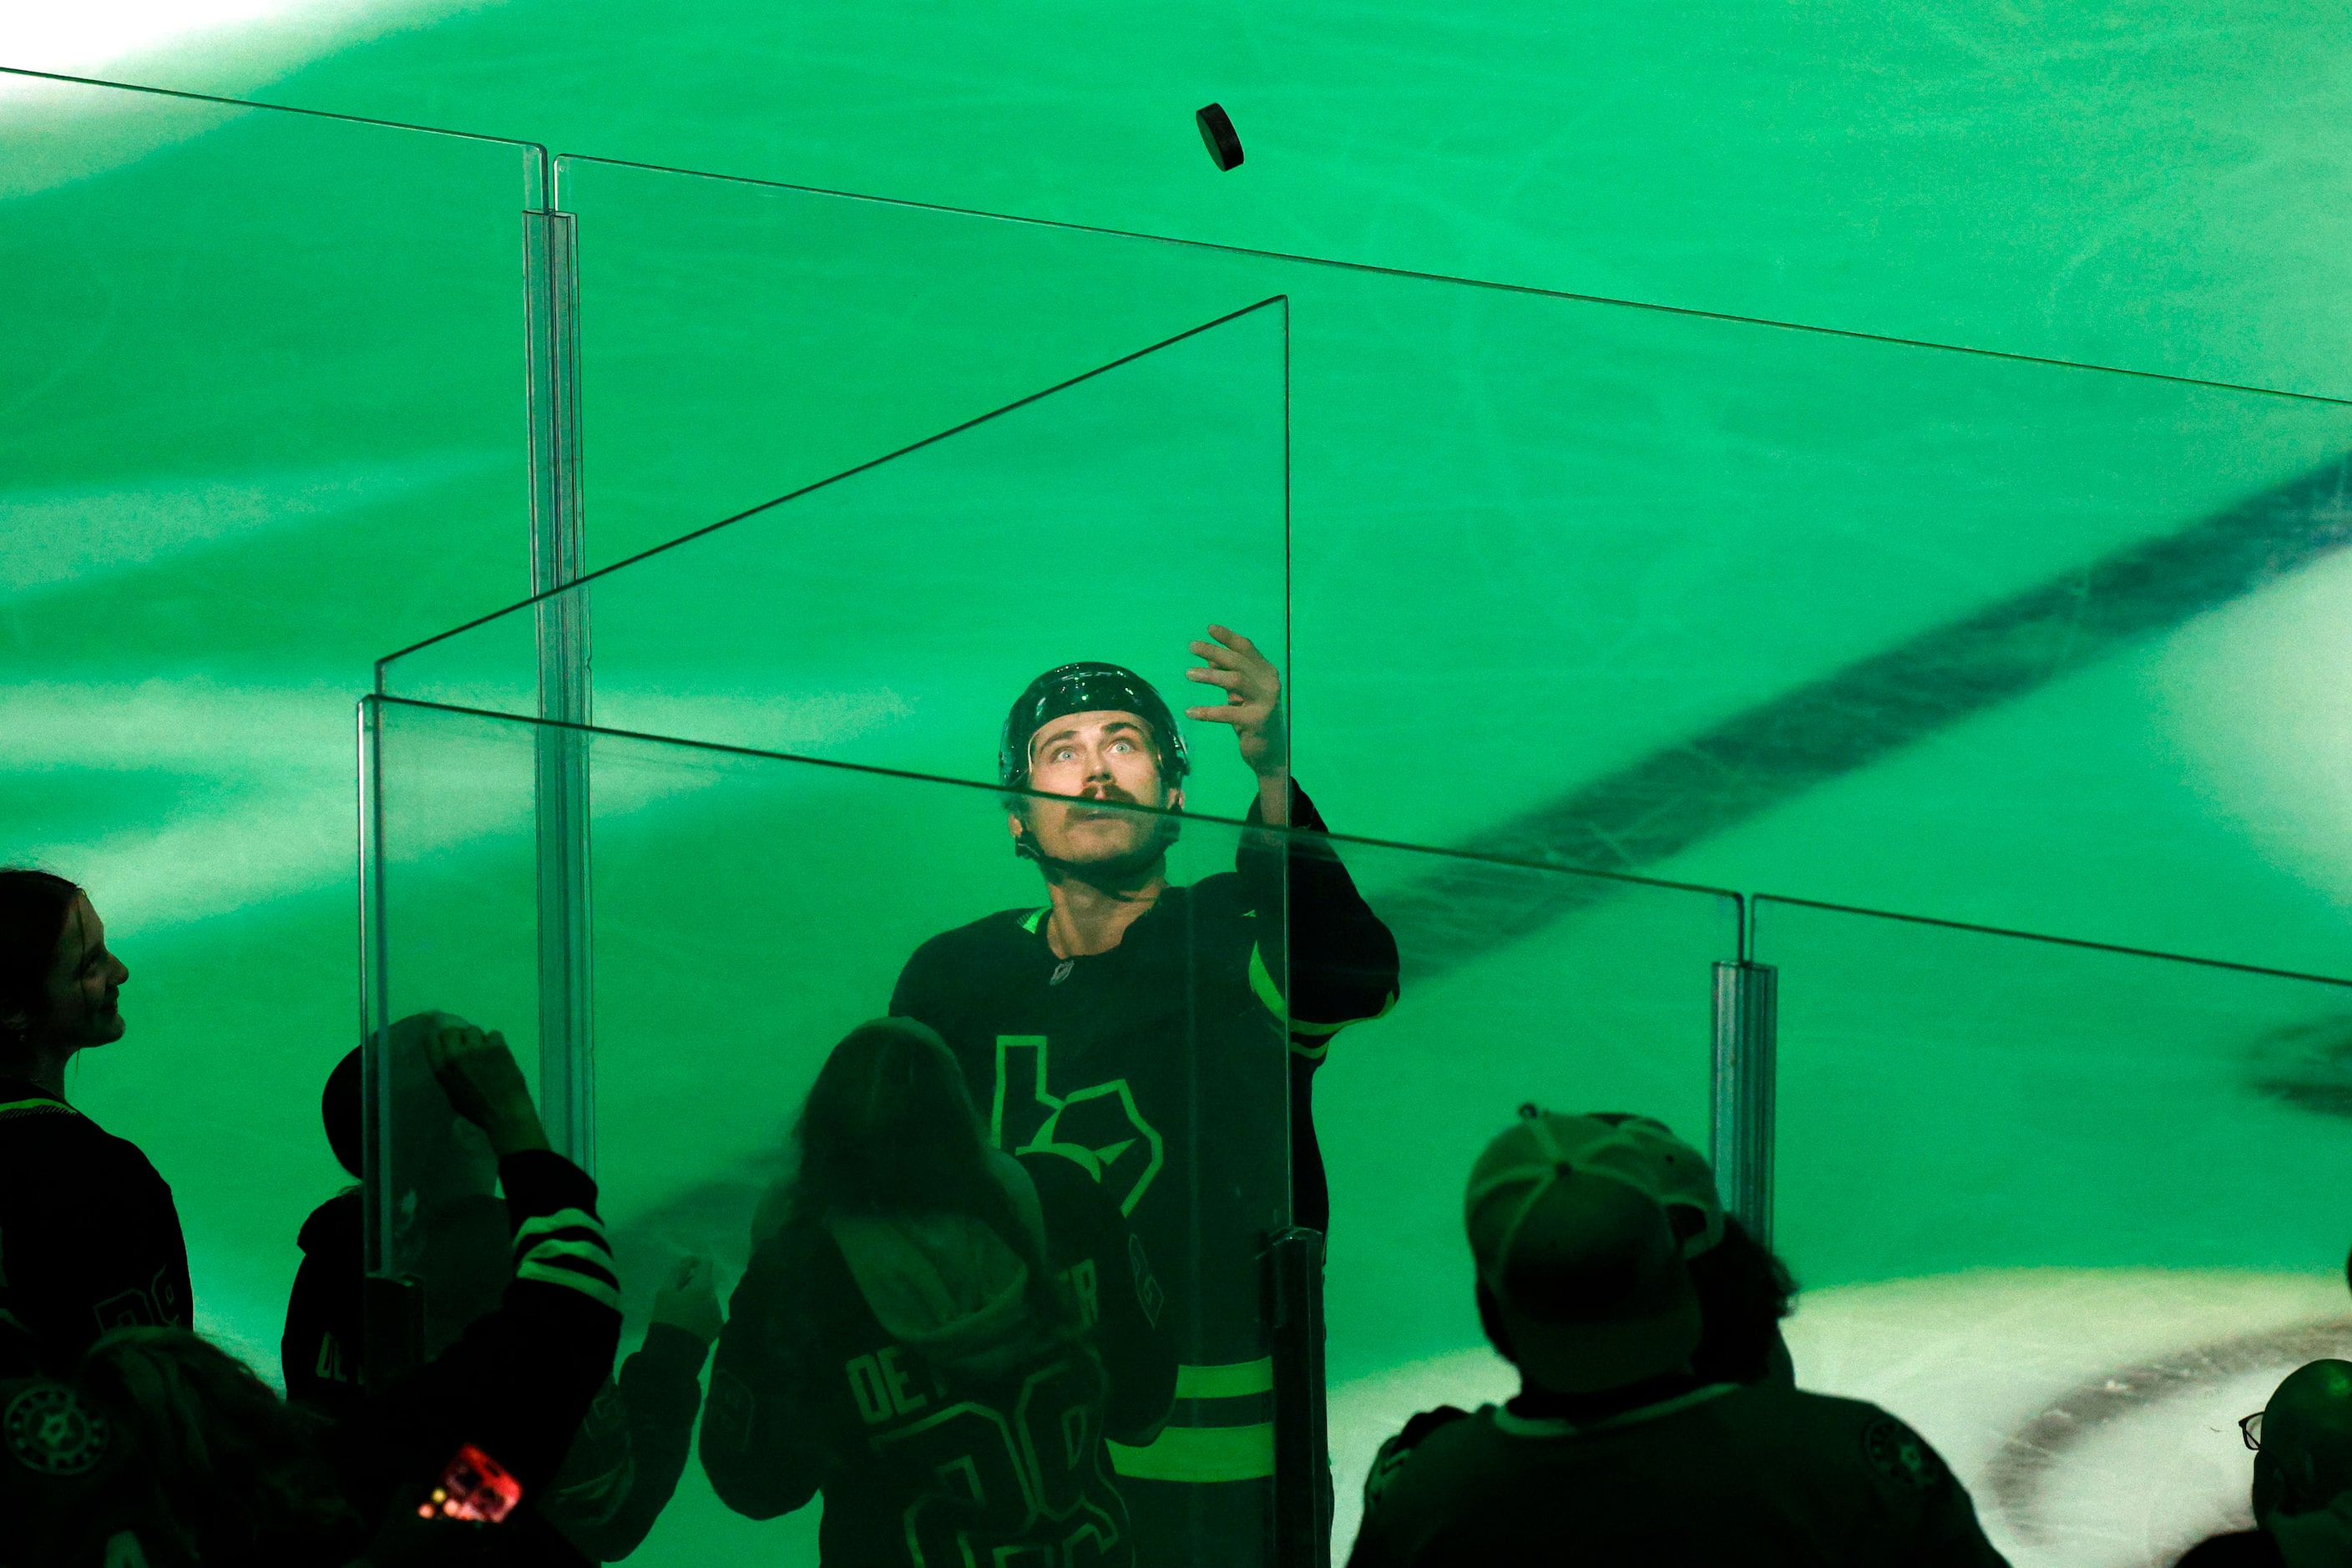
0, 1020, 619, 1568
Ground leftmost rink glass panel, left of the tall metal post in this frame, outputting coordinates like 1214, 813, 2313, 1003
0, 73, 544, 1378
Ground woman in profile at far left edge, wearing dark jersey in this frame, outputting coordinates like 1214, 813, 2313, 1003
0, 870, 193, 1368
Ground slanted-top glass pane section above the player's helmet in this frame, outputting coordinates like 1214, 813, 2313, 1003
381, 299, 1289, 781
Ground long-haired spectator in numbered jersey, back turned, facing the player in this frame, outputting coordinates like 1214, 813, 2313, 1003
703, 1018, 1176, 1568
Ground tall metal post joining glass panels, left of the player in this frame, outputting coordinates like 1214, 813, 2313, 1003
522, 202, 595, 1171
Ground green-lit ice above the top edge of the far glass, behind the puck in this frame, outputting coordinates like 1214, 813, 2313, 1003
45, 0, 2352, 390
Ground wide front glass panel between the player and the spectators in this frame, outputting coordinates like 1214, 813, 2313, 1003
357, 701, 1738, 1563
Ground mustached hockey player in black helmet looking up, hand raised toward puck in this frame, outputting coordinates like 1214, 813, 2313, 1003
892, 625, 1397, 1568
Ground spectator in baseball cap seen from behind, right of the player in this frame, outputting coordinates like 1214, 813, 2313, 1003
1348, 1107, 2001, 1568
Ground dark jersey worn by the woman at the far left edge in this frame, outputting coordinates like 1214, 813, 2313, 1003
0, 1079, 193, 1363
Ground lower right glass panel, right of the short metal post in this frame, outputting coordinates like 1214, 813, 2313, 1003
1754, 898, 2352, 1565
